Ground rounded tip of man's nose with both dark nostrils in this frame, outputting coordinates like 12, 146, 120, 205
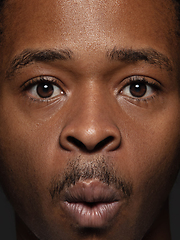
60, 124, 121, 152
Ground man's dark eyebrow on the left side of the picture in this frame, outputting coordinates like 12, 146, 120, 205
6, 49, 73, 77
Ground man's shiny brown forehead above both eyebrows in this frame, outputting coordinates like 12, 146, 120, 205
1, 0, 177, 65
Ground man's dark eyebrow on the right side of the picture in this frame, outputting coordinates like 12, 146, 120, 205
107, 47, 173, 71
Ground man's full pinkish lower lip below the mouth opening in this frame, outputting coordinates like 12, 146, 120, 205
64, 202, 120, 228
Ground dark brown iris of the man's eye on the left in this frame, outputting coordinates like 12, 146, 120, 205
36, 83, 54, 98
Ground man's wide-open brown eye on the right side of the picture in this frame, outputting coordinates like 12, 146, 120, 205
121, 81, 154, 98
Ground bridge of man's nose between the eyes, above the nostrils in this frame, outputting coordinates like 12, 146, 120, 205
71, 81, 110, 127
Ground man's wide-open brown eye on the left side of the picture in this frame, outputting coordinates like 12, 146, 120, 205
24, 78, 64, 100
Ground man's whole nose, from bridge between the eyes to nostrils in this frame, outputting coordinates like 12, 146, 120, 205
60, 80, 120, 151
